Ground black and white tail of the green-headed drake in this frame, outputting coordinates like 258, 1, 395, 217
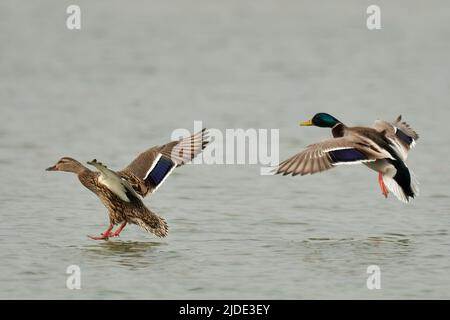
383, 163, 419, 203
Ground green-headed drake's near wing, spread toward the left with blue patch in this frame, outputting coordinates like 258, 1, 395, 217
275, 137, 389, 176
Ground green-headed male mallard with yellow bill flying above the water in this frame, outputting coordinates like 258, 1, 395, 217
276, 113, 419, 202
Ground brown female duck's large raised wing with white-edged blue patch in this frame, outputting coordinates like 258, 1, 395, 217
119, 129, 209, 197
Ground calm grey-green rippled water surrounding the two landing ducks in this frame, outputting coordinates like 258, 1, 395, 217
0, 0, 450, 299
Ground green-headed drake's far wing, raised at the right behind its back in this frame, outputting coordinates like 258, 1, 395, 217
373, 115, 419, 161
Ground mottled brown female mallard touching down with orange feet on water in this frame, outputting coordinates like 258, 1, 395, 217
46, 129, 208, 240
